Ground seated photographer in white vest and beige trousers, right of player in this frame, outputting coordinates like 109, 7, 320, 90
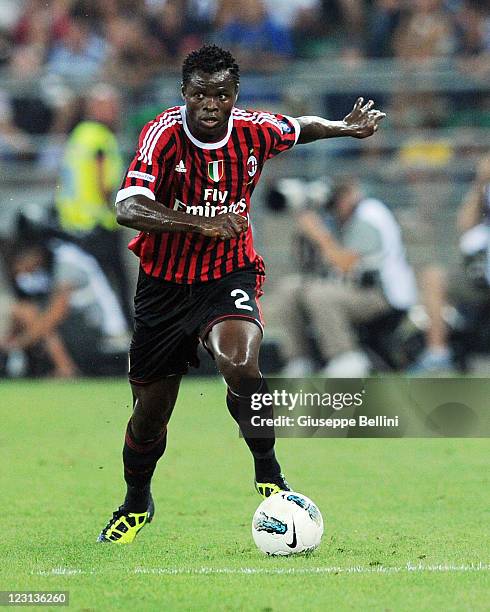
282, 180, 416, 377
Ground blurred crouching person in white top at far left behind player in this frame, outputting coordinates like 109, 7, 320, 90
0, 240, 127, 378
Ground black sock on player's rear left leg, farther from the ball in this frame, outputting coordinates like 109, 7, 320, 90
123, 421, 167, 512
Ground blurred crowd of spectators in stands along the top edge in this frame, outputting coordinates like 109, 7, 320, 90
0, 0, 490, 80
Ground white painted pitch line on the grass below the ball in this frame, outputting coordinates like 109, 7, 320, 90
33, 561, 490, 576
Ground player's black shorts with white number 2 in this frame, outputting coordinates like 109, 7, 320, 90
129, 268, 265, 384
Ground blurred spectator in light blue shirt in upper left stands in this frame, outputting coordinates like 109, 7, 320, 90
47, 2, 107, 82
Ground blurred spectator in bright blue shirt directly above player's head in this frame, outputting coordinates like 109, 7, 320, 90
215, 0, 293, 71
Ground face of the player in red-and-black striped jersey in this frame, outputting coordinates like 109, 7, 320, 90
182, 70, 238, 142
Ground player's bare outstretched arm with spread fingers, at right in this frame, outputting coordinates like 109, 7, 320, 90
297, 98, 386, 144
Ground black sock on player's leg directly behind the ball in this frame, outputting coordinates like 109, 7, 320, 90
226, 383, 281, 482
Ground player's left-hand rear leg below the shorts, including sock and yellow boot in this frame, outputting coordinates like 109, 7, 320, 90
98, 376, 181, 543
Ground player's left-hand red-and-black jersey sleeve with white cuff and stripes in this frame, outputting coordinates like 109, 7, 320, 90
116, 119, 176, 204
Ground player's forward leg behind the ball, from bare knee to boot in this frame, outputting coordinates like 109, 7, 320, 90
206, 319, 289, 496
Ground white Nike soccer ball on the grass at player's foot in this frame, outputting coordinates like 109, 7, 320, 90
252, 491, 323, 555
